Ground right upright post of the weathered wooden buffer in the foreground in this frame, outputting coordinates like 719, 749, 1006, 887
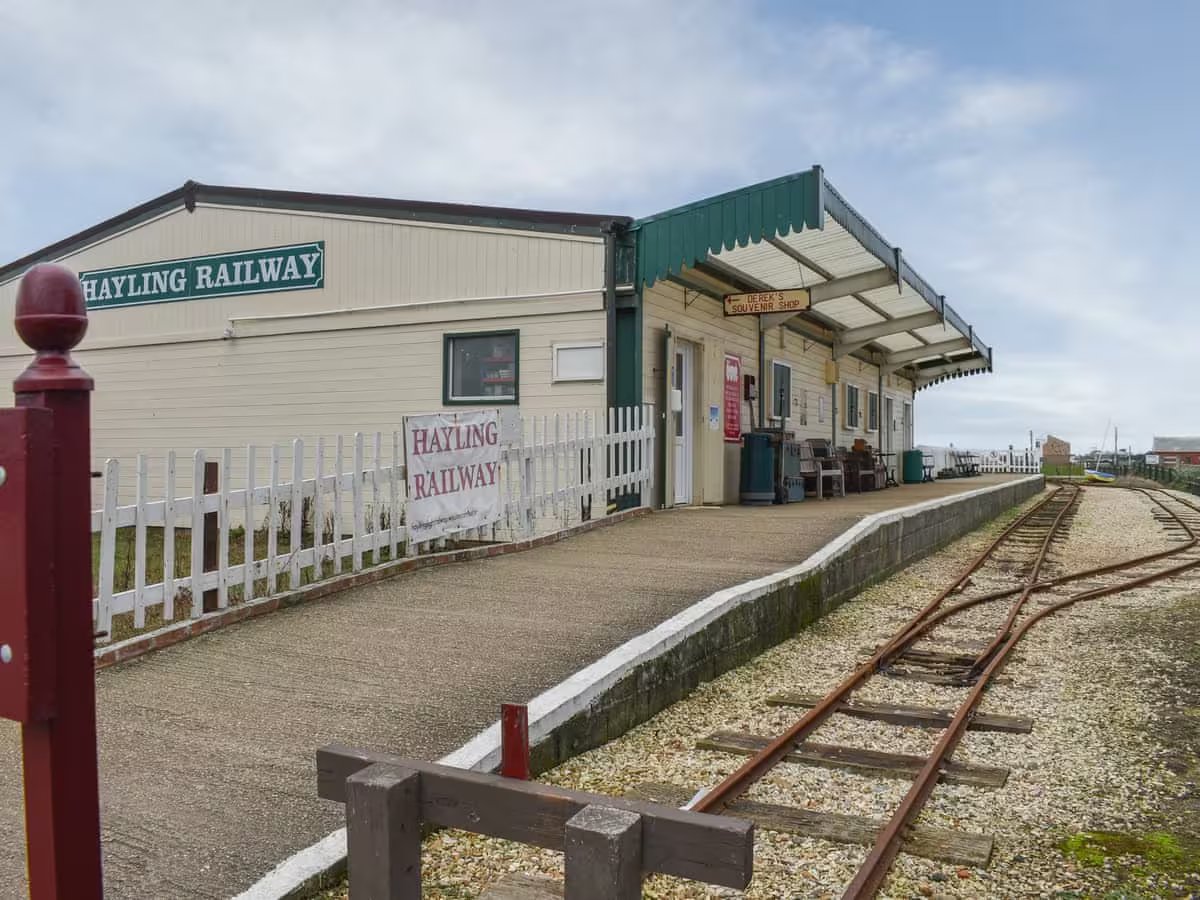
563, 804, 642, 900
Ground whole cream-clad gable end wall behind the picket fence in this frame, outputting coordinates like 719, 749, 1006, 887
0, 204, 605, 504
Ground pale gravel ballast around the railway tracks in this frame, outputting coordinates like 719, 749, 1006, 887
324, 488, 1200, 899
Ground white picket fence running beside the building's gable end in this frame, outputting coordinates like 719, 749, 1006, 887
91, 407, 654, 640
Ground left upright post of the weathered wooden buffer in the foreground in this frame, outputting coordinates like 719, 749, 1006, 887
346, 763, 421, 900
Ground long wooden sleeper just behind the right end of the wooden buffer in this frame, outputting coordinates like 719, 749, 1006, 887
625, 784, 995, 868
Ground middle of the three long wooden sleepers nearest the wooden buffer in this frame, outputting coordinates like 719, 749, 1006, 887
696, 731, 1008, 787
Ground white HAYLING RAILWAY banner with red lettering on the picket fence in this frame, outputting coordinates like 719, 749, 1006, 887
404, 409, 503, 544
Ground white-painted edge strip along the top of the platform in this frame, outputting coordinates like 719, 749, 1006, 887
234, 475, 1043, 900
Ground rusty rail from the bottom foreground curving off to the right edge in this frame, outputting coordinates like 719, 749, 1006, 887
842, 520, 1200, 900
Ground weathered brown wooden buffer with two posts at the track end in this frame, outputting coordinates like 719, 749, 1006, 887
317, 744, 754, 900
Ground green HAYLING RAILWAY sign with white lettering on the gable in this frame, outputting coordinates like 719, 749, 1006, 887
79, 241, 325, 310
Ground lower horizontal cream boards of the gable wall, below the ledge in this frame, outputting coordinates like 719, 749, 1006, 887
34, 313, 606, 505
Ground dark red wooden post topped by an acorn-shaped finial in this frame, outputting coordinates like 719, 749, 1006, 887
13, 265, 103, 900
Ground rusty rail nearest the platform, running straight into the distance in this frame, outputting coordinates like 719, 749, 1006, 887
691, 487, 1079, 812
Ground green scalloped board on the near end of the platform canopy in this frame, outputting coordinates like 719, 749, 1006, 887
631, 167, 824, 287
